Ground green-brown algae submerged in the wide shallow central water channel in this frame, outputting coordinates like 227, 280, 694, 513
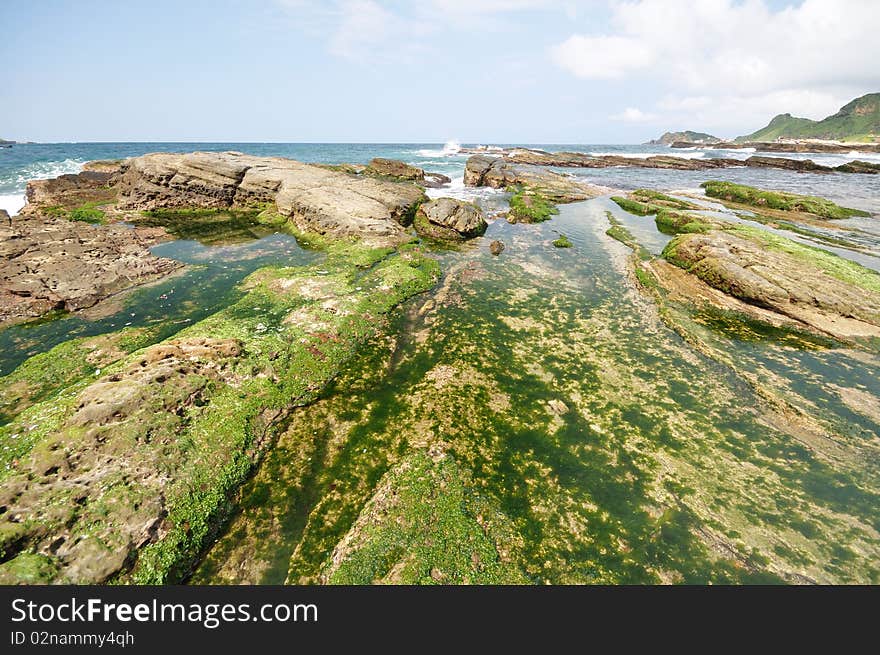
194, 203, 880, 584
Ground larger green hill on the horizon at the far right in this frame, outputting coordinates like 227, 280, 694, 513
736, 93, 880, 142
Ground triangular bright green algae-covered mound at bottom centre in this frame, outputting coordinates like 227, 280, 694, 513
324, 451, 526, 584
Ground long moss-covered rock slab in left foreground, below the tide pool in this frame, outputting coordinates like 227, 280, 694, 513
0, 237, 439, 583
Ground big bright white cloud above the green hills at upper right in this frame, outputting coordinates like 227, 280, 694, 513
550, 0, 880, 132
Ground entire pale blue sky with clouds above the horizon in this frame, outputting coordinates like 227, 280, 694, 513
0, 0, 880, 143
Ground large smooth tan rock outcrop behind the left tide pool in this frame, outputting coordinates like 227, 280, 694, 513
118, 152, 424, 243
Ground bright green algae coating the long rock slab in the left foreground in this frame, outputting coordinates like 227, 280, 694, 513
0, 236, 438, 583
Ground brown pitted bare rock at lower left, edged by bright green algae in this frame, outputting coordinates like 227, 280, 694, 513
0, 338, 240, 584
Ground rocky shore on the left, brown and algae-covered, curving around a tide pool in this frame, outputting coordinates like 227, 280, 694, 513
0, 153, 454, 584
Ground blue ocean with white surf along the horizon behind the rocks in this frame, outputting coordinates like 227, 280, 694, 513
0, 142, 880, 214
